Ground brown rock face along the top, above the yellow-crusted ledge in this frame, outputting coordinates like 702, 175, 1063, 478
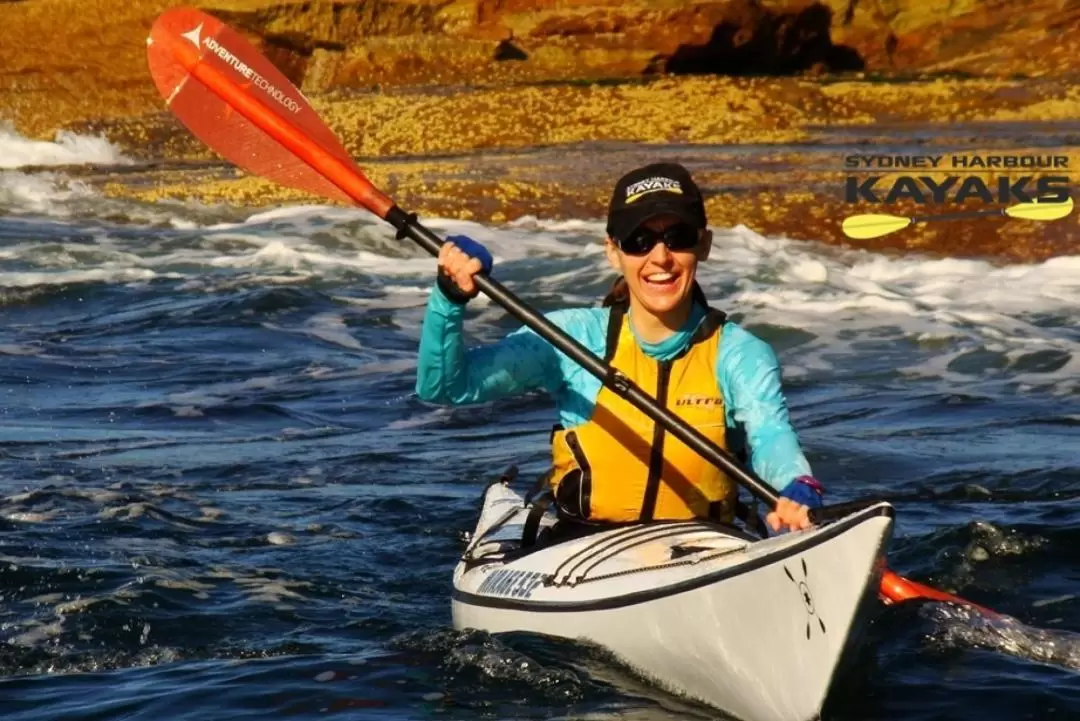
0, 0, 1080, 134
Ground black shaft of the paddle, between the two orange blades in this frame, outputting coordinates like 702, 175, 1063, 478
386, 205, 852, 522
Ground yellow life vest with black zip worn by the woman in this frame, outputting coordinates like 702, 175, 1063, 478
548, 303, 738, 522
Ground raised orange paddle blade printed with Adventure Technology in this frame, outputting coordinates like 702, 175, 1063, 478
147, 8, 393, 217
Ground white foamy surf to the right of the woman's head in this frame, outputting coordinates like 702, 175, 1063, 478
701, 227, 1080, 393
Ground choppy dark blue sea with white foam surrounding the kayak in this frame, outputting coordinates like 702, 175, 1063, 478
0, 126, 1080, 721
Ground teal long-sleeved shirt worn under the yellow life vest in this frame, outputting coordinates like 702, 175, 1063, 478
416, 286, 811, 491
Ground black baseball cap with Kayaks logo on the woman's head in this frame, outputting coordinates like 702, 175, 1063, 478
607, 163, 707, 241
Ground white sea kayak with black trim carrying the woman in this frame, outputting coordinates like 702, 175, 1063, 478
453, 481, 893, 721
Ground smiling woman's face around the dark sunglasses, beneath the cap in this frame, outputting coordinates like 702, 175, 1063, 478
605, 215, 713, 316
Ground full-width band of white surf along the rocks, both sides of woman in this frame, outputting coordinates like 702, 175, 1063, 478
0, 197, 1080, 394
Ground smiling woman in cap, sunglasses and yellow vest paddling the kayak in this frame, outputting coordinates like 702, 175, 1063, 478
416, 163, 823, 531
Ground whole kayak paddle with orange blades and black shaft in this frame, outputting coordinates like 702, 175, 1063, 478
147, 8, 993, 608
